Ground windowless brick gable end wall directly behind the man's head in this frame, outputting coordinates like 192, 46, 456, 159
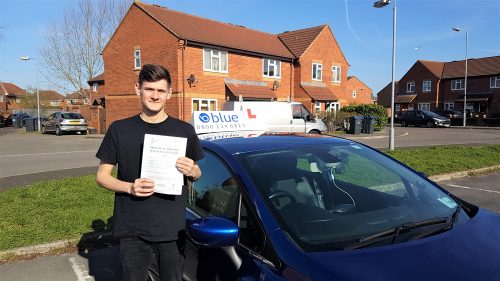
99, 5, 179, 126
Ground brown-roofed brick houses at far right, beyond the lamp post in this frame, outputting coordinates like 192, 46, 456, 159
377, 56, 500, 117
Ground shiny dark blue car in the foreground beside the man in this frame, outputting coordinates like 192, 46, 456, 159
150, 134, 500, 281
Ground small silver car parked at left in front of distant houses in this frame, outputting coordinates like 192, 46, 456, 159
42, 112, 87, 136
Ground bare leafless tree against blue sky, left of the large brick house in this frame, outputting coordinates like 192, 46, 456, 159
40, 0, 131, 94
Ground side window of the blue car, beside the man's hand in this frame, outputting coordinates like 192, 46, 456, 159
188, 152, 239, 219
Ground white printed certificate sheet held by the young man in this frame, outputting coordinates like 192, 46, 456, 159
141, 134, 187, 195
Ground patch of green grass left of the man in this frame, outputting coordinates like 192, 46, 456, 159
0, 175, 114, 251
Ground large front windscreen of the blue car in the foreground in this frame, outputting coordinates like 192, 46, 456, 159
238, 143, 458, 251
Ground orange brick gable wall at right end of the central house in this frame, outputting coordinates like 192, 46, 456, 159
295, 27, 349, 111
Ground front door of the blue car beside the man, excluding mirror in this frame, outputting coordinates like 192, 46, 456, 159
184, 151, 266, 281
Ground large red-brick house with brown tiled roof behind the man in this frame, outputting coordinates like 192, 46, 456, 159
100, 1, 369, 127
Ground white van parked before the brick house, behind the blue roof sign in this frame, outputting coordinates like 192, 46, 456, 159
222, 101, 327, 134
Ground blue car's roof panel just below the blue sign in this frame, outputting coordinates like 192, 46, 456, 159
201, 133, 355, 154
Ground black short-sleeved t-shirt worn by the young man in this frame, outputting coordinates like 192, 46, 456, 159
96, 115, 203, 241
